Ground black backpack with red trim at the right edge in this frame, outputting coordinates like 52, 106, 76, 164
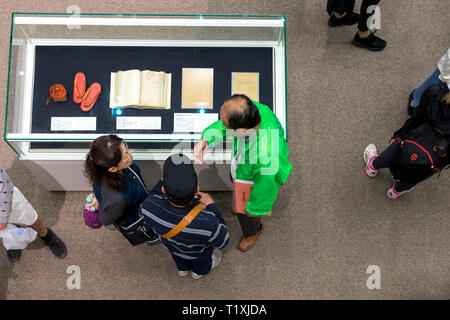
390, 122, 449, 184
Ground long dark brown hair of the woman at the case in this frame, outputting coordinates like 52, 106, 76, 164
84, 134, 126, 191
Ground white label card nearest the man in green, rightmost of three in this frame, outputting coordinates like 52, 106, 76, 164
173, 113, 219, 132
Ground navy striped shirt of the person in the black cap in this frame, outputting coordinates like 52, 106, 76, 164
140, 181, 230, 260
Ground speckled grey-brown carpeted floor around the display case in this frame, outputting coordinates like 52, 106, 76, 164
0, 0, 450, 299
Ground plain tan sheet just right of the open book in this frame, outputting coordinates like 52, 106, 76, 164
181, 68, 214, 109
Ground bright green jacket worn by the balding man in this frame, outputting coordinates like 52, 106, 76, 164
202, 101, 292, 216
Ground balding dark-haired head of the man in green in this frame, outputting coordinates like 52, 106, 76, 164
224, 94, 261, 130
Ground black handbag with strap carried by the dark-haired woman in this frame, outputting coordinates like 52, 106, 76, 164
114, 168, 158, 246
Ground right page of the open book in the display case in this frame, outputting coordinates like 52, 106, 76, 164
140, 70, 170, 109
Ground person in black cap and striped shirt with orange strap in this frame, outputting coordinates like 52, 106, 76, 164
141, 154, 230, 279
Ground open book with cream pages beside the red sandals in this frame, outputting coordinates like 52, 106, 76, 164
109, 69, 172, 109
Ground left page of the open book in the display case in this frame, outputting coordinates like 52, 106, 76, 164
114, 70, 141, 107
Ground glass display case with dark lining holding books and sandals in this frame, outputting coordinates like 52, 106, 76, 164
4, 13, 287, 190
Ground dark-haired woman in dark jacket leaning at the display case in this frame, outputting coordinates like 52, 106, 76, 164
85, 135, 158, 241
